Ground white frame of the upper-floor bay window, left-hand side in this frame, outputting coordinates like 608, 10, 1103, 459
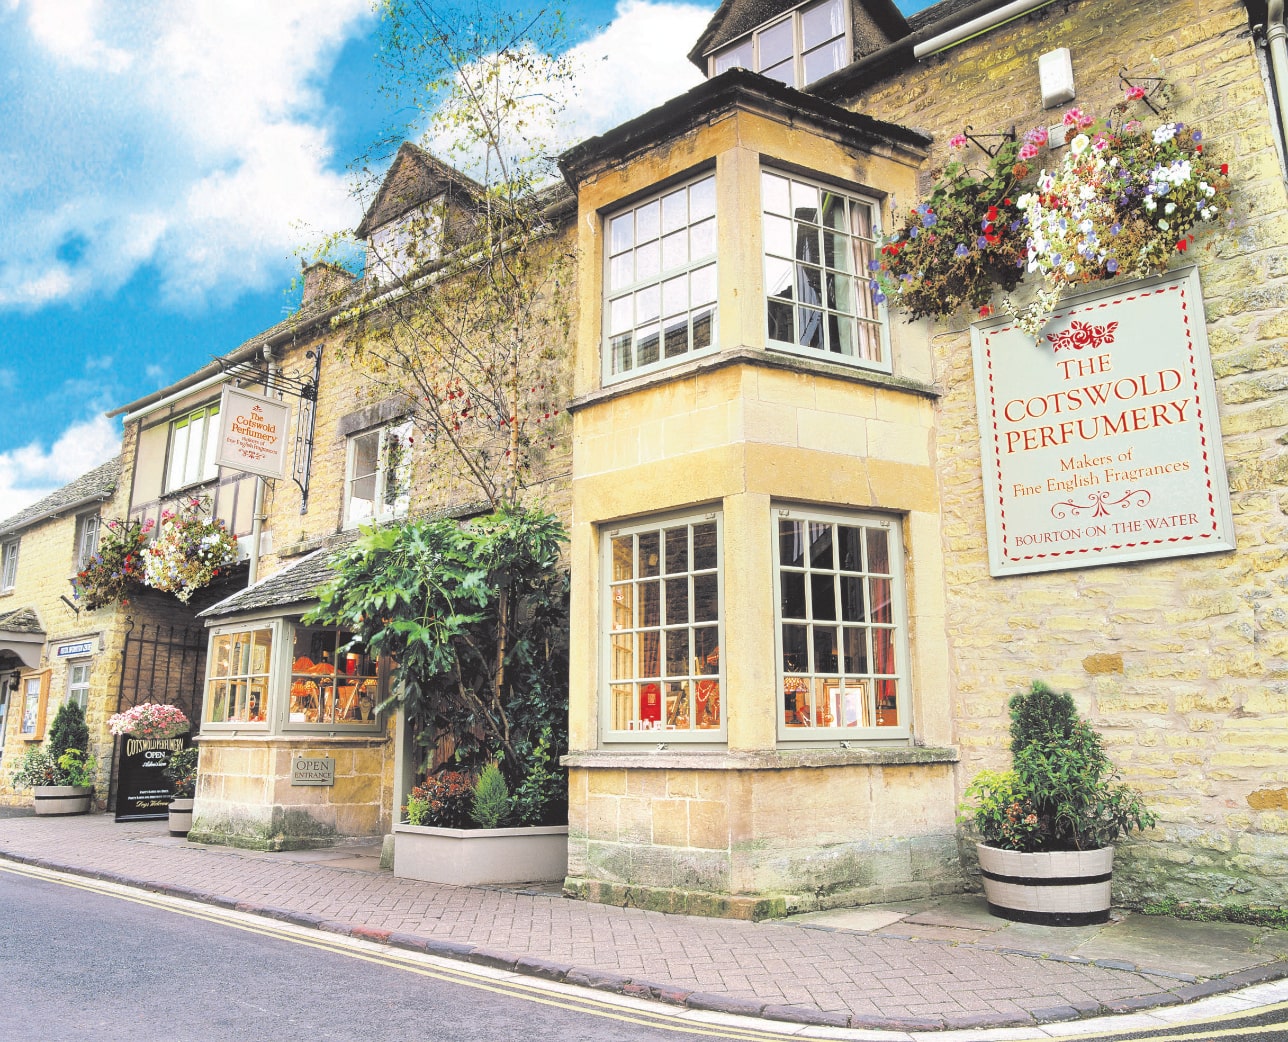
601, 169, 720, 384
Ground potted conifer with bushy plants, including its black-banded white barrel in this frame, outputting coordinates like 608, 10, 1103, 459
961, 680, 1155, 926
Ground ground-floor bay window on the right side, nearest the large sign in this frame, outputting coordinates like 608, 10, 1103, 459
774, 510, 909, 739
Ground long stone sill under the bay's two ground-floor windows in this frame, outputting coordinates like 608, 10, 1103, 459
560, 746, 961, 770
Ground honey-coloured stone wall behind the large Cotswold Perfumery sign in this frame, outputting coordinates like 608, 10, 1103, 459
848, 0, 1288, 904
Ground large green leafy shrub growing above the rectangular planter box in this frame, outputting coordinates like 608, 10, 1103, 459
307, 507, 568, 784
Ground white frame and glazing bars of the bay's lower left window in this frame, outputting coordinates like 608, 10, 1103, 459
599, 510, 729, 746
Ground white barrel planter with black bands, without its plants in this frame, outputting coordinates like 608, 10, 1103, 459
976, 844, 1114, 926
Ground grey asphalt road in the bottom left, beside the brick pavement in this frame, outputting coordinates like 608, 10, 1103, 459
0, 866, 767, 1042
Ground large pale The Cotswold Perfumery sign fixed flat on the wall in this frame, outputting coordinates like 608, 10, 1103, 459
972, 269, 1234, 576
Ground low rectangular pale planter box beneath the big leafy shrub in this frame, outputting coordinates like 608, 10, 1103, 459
394, 824, 568, 886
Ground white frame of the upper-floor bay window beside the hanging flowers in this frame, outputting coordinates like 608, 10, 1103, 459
760, 166, 893, 372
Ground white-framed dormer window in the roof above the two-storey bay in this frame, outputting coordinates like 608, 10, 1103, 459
708, 0, 851, 88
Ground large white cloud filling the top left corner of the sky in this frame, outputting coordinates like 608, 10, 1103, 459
0, 0, 372, 310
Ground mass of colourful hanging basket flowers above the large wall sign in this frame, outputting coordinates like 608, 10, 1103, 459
869, 89, 1230, 339
